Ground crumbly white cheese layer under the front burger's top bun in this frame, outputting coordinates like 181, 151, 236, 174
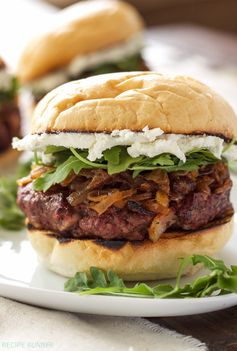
12, 127, 230, 162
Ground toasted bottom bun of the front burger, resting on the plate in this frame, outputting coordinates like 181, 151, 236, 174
28, 220, 233, 281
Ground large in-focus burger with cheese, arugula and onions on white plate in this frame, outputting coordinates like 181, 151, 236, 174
13, 72, 237, 280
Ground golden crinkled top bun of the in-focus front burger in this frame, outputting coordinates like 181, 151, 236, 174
32, 72, 237, 139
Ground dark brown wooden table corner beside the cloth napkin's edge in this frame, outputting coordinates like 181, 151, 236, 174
149, 307, 237, 351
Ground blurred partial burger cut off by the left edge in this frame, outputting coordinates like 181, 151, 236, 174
0, 58, 21, 167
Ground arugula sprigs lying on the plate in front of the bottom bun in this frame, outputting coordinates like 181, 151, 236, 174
64, 255, 237, 299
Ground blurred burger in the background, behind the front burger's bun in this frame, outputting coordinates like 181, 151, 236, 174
17, 0, 147, 102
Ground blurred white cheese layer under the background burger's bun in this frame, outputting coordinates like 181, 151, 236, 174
28, 34, 143, 92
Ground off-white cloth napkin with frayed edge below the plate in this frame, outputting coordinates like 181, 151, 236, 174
0, 298, 207, 351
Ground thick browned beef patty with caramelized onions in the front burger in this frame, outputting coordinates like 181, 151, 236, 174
18, 162, 233, 241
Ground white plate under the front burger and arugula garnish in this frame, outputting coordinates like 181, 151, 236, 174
0, 178, 237, 317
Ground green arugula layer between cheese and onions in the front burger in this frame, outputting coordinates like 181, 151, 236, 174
33, 146, 225, 191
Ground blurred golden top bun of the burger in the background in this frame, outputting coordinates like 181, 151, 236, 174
17, 0, 143, 82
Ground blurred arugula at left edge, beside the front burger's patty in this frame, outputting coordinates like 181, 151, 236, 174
0, 162, 31, 230
